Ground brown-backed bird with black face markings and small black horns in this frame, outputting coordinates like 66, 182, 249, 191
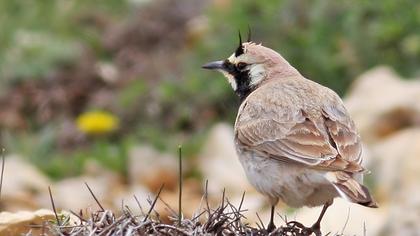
202, 33, 378, 235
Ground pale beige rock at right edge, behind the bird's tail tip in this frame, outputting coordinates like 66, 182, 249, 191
371, 127, 420, 235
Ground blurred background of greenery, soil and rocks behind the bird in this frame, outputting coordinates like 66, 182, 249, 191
0, 0, 420, 235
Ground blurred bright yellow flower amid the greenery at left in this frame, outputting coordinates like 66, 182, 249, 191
76, 111, 119, 135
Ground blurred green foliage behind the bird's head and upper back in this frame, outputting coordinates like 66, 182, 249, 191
199, 0, 420, 94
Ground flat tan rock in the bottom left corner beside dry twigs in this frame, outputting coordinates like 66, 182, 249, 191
0, 209, 55, 236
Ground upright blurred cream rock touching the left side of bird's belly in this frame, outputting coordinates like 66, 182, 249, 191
198, 124, 254, 198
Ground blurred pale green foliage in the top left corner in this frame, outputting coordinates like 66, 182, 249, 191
0, 0, 126, 85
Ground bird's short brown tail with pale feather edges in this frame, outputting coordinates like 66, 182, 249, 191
327, 171, 378, 208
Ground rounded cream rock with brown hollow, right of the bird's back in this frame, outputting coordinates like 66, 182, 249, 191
345, 66, 420, 143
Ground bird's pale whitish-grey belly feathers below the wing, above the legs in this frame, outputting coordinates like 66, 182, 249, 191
239, 151, 338, 207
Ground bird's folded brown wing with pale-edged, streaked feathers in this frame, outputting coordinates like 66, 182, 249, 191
235, 94, 363, 172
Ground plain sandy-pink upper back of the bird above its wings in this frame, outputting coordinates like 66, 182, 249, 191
237, 76, 342, 122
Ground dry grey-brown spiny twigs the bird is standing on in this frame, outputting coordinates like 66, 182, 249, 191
34, 184, 324, 236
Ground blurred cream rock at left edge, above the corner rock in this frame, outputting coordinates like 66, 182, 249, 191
0, 155, 51, 211
